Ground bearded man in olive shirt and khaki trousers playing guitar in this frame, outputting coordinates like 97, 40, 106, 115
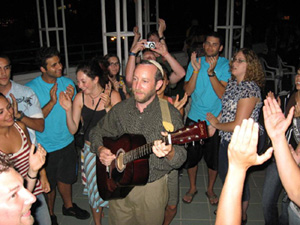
90, 60, 186, 225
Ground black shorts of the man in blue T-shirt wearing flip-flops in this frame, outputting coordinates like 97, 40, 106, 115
184, 118, 220, 170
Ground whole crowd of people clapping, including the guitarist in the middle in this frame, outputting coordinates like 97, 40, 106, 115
0, 19, 300, 225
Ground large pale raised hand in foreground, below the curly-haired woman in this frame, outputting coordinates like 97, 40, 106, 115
228, 119, 273, 170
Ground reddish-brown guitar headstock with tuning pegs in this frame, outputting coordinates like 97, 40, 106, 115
170, 121, 208, 144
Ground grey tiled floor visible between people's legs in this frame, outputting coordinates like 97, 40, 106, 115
55, 157, 282, 225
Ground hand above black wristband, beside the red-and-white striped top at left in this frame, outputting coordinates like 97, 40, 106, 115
29, 144, 47, 173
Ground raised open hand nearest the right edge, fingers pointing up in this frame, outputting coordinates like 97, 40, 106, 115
263, 97, 294, 140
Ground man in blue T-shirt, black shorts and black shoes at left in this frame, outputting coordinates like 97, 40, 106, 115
26, 48, 90, 224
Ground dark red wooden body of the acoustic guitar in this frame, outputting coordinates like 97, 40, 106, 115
96, 134, 149, 200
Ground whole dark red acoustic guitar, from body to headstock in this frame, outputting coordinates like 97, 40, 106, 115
96, 121, 208, 200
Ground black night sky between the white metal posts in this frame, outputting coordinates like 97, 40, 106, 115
0, 0, 299, 50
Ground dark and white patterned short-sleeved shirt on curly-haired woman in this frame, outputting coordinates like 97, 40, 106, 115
219, 79, 263, 142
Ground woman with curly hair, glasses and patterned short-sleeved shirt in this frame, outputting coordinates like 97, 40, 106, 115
207, 48, 265, 224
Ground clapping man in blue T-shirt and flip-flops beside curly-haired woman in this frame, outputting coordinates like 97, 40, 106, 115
182, 32, 230, 205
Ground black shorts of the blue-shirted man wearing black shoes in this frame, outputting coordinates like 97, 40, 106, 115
45, 141, 78, 190
